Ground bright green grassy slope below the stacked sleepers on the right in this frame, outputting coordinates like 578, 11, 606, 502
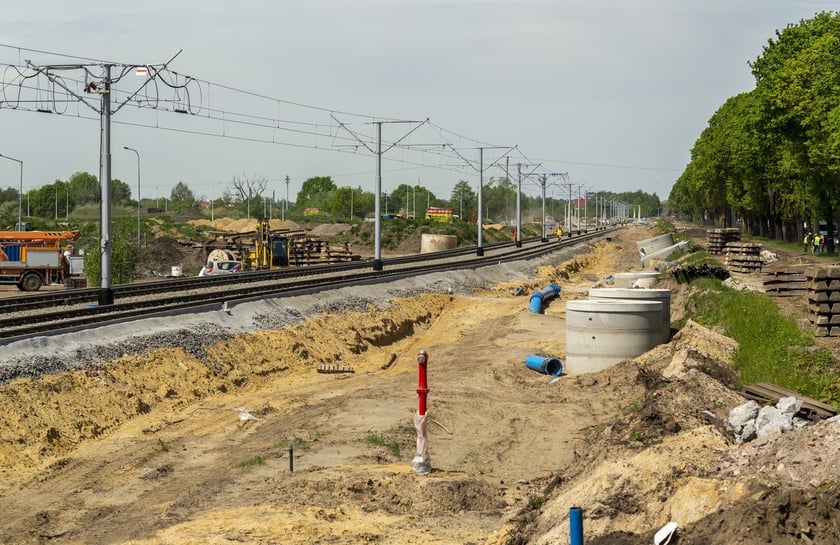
688, 278, 840, 403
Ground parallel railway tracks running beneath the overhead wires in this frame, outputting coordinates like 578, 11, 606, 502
0, 230, 611, 344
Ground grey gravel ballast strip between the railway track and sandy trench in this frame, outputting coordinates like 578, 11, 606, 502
0, 240, 590, 384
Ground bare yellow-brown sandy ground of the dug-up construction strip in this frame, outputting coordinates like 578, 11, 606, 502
0, 223, 840, 545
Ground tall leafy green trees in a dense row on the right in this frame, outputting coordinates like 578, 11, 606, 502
668, 12, 840, 241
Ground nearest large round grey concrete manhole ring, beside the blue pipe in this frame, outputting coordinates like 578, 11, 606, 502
564, 299, 663, 375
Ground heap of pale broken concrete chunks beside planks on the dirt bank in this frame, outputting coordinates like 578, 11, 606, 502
726, 397, 808, 443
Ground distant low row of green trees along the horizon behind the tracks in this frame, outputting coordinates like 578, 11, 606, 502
0, 168, 660, 228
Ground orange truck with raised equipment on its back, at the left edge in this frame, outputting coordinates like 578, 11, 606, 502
0, 231, 81, 291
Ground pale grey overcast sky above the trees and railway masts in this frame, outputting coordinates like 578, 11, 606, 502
0, 0, 836, 206
